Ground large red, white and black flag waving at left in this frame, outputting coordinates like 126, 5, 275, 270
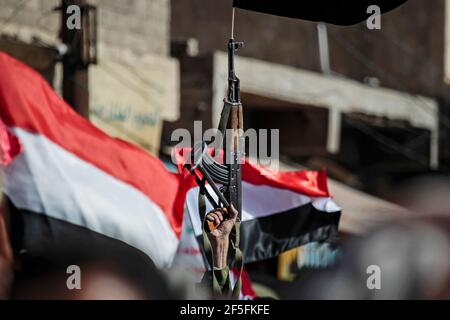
0, 52, 183, 268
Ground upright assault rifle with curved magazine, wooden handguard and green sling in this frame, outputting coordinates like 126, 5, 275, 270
185, 38, 243, 298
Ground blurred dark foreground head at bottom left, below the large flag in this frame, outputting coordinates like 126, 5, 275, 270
0, 198, 184, 300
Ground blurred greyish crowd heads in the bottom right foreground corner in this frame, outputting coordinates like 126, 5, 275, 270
285, 178, 450, 299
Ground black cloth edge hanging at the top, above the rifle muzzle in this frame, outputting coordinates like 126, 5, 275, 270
233, 0, 408, 26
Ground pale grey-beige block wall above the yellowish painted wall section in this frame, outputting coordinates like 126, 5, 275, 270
0, 0, 170, 57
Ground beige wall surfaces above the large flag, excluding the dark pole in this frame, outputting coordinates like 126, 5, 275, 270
0, 0, 179, 154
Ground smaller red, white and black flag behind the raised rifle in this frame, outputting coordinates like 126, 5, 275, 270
174, 149, 341, 281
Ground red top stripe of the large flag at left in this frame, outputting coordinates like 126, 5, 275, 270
0, 52, 183, 236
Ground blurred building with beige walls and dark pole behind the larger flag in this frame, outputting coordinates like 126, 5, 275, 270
0, 0, 179, 154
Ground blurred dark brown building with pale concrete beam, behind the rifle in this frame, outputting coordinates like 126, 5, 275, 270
167, 0, 450, 199
